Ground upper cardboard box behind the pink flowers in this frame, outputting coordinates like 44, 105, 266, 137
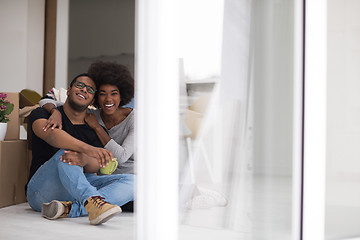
5, 93, 20, 140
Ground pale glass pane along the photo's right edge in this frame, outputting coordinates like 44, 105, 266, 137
325, 0, 360, 239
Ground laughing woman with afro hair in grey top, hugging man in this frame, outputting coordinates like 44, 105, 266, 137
86, 61, 135, 174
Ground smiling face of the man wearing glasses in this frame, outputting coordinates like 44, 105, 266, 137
67, 76, 96, 111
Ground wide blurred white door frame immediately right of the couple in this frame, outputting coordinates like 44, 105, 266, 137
135, 0, 179, 240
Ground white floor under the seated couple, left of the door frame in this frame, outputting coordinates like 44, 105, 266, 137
0, 203, 135, 240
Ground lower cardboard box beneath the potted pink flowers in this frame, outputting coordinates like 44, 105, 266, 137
0, 140, 29, 207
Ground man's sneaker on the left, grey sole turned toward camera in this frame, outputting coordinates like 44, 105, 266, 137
41, 200, 72, 220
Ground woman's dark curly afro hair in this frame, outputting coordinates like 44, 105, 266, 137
88, 61, 134, 107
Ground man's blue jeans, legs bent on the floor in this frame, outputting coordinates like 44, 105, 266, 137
27, 149, 134, 217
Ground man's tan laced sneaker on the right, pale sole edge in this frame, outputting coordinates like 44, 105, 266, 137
84, 196, 121, 225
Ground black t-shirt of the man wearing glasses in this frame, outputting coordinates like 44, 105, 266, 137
29, 106, 103, 181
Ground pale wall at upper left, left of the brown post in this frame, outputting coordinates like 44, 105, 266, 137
0, 0, 45, 93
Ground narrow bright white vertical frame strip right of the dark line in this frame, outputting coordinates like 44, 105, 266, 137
302, 0, 327, 240
